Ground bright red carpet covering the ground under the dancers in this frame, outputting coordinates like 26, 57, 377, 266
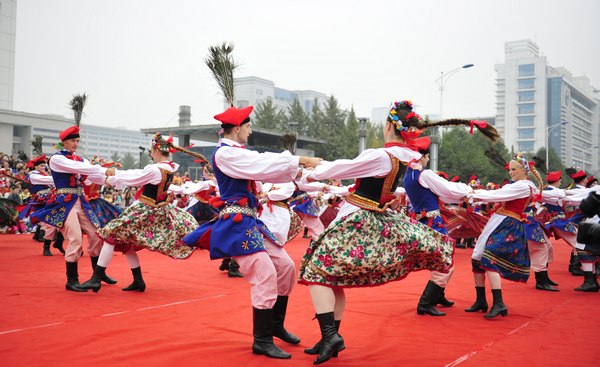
0, 235, 600, 367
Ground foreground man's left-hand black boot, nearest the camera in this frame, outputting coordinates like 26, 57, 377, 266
252, 308, 292, 359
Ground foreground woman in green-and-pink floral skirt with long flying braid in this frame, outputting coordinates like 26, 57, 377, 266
299, 101, 497, 364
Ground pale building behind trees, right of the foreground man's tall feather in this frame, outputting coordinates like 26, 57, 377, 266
233, 76, 327, 115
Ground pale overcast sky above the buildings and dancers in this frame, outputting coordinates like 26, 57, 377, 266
13, 0, 600, 129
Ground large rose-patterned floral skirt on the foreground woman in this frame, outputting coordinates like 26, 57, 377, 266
299, 210, 454, 287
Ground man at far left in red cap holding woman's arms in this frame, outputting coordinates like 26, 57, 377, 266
31, 125, 113, 292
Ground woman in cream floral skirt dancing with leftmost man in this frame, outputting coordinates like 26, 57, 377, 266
82, 133, 199, 292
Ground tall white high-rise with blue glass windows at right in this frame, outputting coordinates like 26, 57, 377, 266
496, 40, 600, 172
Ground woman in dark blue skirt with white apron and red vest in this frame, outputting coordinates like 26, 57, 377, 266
465, 154, 542, 318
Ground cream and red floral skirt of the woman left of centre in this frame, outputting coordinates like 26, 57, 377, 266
98, 201, 198, 259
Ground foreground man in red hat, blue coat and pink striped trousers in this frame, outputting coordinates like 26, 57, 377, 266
184, 106, 321, 359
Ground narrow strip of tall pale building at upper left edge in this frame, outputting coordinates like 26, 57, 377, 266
0, 0, 17, 110
